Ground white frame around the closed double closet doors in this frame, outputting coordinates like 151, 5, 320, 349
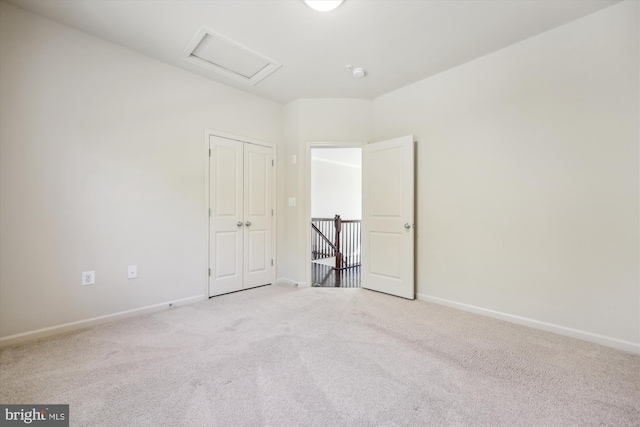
203, 129, 278, 298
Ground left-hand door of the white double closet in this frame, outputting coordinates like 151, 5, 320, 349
209, 136, 244, 296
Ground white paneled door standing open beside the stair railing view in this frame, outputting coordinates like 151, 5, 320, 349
362, 135, 415, 299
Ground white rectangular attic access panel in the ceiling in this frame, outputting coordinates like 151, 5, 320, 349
185, 27, 281, 86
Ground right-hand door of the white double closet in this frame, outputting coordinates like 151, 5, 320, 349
244, 144, 273, 289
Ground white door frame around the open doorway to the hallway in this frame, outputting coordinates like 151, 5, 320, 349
300, 141, 362, 286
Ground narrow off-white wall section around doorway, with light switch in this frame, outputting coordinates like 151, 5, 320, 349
278, 99, 373, 283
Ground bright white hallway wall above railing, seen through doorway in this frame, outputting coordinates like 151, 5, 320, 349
311, 148, 362, 219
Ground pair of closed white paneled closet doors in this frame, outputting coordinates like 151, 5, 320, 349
209, 136, 273, 296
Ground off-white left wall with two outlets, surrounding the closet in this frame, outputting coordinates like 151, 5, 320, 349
0, 3, 283, 338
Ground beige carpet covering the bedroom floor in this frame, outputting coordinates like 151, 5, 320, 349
0, 286, 640, 426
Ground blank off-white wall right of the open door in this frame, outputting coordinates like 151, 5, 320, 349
374, 2, 640, 350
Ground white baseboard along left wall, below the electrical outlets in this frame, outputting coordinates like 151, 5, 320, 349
0, 295, 207, 347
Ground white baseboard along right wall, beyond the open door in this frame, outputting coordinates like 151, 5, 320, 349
416, 294, 640, 354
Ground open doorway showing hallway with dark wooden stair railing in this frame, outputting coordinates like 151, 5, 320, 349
309, 147, 362, 288
